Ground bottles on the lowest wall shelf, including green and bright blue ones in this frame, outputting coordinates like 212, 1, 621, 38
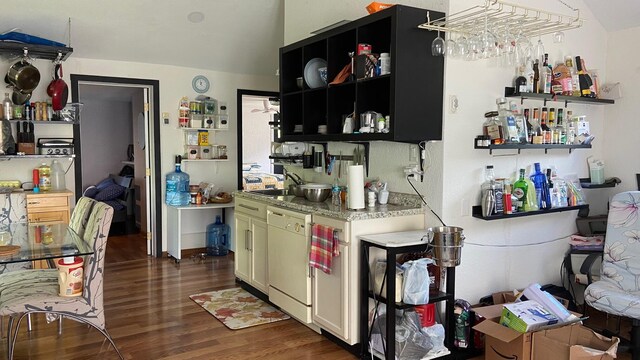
481, 163, 585, 217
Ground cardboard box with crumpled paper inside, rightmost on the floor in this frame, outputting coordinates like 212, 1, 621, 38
531, 324, 620, 360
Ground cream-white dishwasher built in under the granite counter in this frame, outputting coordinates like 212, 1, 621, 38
267, 206, 312, 324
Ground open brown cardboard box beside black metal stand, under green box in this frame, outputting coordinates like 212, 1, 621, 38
473, 304, 582, 360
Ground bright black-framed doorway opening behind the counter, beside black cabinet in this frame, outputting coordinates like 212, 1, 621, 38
237, 89, 282, 190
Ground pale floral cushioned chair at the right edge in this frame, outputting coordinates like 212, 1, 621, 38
584, 191, 640, 319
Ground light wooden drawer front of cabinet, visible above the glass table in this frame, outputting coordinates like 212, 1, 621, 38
27, 190, 73, 224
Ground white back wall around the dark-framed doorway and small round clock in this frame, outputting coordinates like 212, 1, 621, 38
0, 55, 278, 250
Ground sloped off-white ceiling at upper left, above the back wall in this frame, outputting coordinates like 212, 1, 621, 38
0, 0, 284, 75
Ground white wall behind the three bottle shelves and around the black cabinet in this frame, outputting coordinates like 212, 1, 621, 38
285, 0, 607, 303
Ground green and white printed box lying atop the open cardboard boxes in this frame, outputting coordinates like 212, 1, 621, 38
500, 300, 559, 333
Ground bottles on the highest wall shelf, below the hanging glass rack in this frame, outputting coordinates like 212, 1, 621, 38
515, 54, 599, 98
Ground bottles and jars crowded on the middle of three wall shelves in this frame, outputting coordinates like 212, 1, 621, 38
476, 98, 593, 147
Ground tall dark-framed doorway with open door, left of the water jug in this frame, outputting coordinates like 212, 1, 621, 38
71, 74, 162, 257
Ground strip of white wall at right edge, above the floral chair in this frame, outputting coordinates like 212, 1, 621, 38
604, 27, 640, 196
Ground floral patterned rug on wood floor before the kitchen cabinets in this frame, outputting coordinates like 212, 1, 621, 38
189, 288, 290, 330
